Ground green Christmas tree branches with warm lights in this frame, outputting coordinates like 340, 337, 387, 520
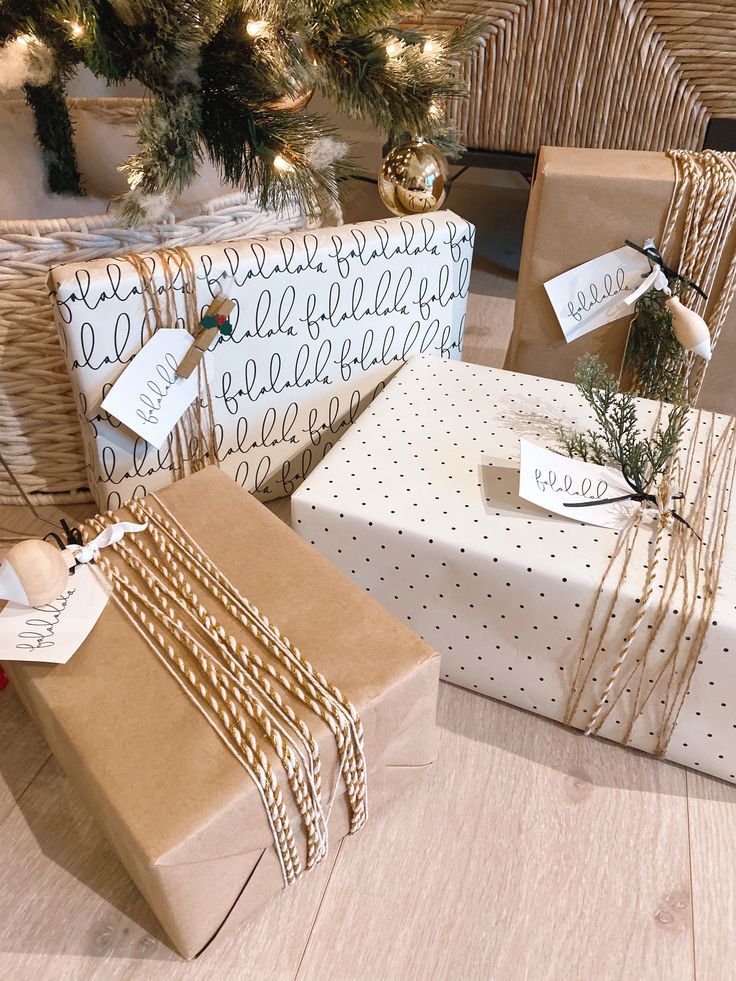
0, 0, 478, 221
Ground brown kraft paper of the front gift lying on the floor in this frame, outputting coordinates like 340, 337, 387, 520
7, 468, 439, 957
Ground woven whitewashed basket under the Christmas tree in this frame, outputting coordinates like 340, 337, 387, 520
0, 100, 328, 504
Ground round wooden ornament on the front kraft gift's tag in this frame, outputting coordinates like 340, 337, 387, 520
0, 538, 74, 606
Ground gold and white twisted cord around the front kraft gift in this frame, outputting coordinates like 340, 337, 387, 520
83, 495, 368, 885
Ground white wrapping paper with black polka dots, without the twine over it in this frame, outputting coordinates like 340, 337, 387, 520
292, 358, 736, 781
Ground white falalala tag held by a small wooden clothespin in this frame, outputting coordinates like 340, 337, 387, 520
102, 327, 197, 450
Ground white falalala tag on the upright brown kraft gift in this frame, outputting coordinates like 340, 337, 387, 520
544, 245, 650, 343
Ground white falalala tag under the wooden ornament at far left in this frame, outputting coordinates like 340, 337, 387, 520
0, 565, 110, 664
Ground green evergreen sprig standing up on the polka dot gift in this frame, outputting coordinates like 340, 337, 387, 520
558, 354, 688, 495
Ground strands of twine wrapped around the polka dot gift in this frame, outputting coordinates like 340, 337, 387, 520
564, 411, 736, 756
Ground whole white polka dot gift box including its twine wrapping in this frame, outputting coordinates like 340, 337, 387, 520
292, 357, 736, 782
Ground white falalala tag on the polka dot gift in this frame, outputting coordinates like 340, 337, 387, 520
519, 439, 638, 528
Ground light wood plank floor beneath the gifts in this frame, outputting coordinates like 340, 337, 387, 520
0, 180, 736, 981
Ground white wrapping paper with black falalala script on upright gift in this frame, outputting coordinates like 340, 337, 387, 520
51, 211, 475, 510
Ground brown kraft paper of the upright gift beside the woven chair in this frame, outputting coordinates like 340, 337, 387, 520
504, 147, 736, 414
